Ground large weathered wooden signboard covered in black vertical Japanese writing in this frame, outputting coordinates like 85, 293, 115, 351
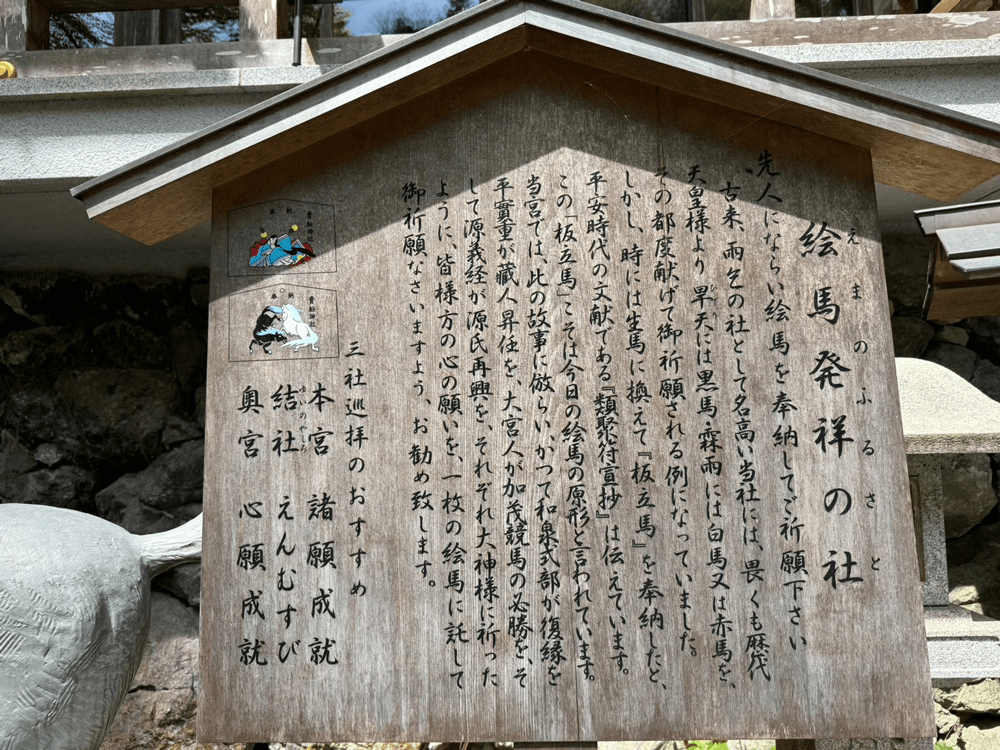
199, 53, 933, 741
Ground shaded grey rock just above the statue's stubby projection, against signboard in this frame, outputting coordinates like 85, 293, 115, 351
97, 440, 205, 534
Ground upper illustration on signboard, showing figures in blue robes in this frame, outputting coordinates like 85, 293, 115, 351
229, 200, 337, 276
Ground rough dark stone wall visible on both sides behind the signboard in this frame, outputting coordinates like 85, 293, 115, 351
0, 236, 1000, 750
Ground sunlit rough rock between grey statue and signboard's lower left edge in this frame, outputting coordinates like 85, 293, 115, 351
101, 592, 198, 750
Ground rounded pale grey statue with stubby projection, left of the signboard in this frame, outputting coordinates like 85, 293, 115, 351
0, 504, 201, 750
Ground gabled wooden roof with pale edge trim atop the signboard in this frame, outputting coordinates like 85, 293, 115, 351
72, 0, 1000, 244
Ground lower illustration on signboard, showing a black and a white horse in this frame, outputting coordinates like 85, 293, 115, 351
229, 284, 340, 362
